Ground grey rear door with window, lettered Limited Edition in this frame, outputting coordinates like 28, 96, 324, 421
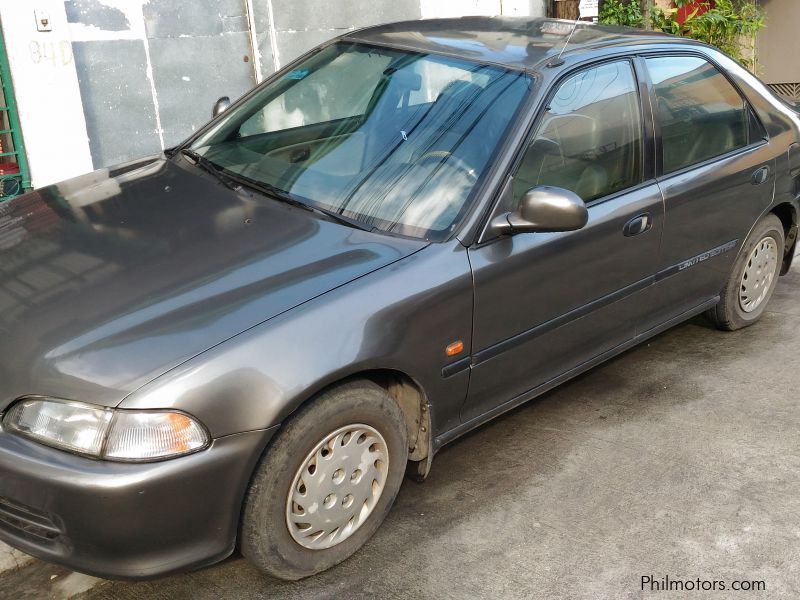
642, 54, 775, 328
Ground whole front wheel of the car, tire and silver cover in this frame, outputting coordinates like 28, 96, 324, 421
241, 381, 408, 579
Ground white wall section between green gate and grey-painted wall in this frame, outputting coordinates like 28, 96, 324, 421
0, 0, 92, 187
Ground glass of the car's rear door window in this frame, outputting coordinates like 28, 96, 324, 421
647, 56, 749, 173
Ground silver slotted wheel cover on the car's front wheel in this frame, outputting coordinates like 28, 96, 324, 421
286, 424, 389, 550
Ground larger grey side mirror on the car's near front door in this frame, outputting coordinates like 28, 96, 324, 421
491, 185, 589, 234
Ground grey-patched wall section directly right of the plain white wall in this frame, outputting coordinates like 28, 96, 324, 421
64, 0, 255, 168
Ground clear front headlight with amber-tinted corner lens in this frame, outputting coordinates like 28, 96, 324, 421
3, 398, 211, 462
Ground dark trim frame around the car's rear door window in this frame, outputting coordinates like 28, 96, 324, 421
637, 49, 770, 182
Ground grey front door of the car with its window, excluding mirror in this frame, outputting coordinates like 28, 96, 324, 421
462, 60, 663, 421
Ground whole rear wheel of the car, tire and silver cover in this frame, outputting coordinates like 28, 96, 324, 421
706, 215, 785, 331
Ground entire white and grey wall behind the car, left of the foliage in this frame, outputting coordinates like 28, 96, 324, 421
0, 0, 545, 187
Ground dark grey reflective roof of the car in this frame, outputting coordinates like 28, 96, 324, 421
343, 17, 686, 69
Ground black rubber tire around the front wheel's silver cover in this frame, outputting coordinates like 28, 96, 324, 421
240, 380, 408, 580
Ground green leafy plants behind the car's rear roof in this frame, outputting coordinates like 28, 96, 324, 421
650, 0, 765, 68
